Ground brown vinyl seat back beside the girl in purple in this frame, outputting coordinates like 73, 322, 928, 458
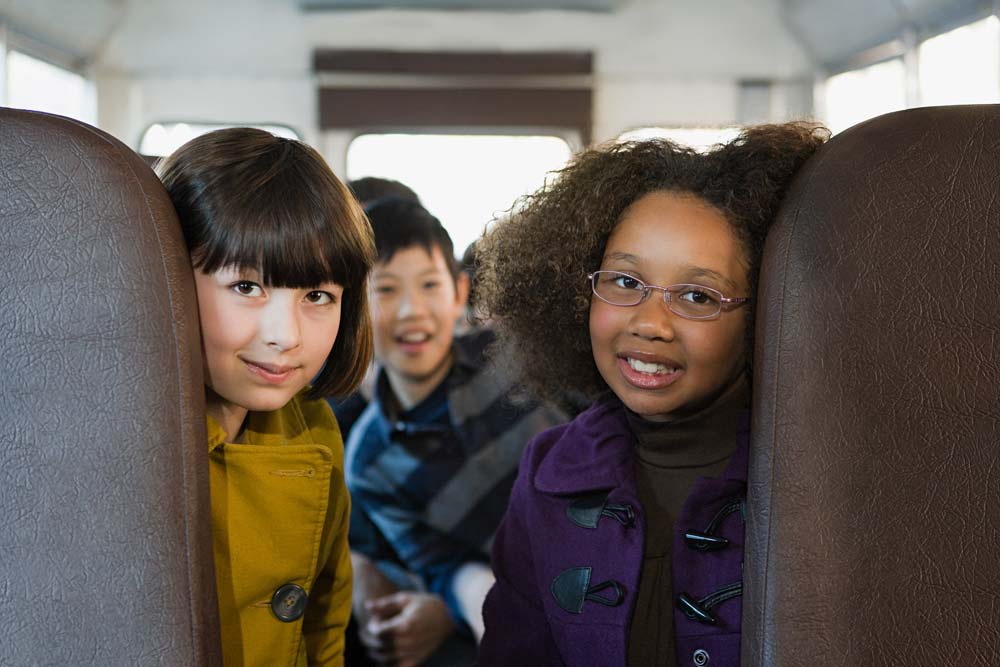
743, 106, 1000, 667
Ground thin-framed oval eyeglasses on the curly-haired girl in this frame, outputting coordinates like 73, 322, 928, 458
587, 271, 750, 320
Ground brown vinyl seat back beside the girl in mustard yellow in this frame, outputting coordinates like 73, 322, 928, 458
0, 109, 219, 665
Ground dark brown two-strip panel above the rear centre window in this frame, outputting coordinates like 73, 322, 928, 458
314, 50, 593, 145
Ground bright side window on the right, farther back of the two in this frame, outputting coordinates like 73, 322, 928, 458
825, 58, 906, 132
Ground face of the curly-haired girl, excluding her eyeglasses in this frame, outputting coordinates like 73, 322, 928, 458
590, 192, 749, 421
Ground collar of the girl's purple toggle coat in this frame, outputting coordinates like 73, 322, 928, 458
534, 394, 750, 495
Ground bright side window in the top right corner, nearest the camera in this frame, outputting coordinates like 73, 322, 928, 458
919, 16, 1000, 106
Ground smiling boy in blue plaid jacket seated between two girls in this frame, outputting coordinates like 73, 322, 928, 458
346, 199, 564, 665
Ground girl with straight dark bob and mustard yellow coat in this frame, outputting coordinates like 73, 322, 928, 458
158, 128, 375, 665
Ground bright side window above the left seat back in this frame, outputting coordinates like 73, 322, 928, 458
7, 51, 97, 125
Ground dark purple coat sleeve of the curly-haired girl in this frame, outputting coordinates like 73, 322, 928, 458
477, 436, 564, 667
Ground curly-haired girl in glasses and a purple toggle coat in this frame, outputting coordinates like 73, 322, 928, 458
477, 123, 829, 667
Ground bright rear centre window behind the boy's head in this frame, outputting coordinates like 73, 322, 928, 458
347, 134, 570, 256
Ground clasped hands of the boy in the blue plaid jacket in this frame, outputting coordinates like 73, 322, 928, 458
362, 591, 455, 667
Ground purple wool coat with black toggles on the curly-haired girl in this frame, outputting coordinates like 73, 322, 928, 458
478, 397, 749, 667
